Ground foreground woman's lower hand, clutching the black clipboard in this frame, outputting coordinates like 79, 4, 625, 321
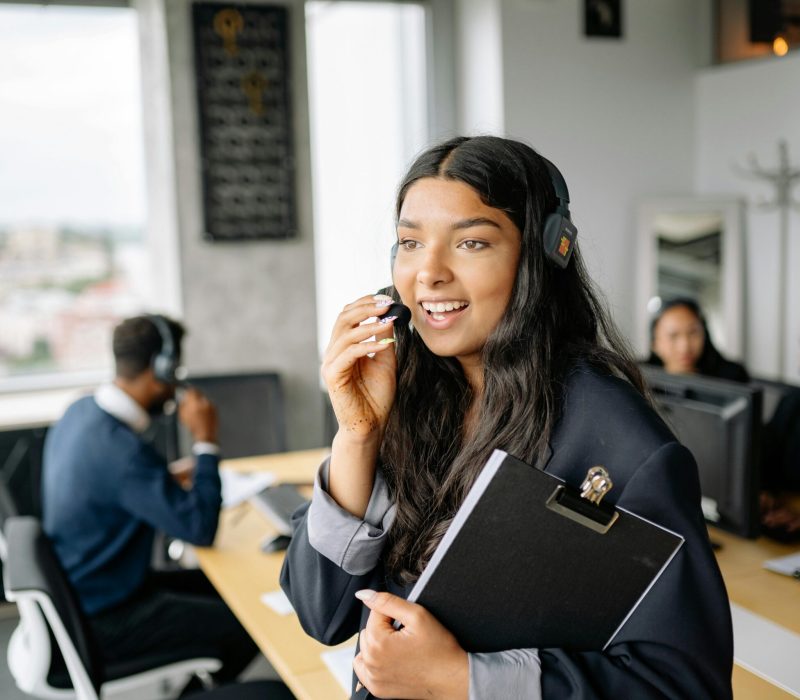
353, 590, 469, 700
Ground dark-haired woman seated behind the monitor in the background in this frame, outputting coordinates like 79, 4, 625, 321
647, 298, 800, 541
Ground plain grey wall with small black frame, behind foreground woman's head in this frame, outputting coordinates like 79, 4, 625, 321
459, 0, 711, 344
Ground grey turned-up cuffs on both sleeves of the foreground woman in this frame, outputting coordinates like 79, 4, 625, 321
307, 460, 541, 700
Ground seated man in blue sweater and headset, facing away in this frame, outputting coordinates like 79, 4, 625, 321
42, 316, 257, 681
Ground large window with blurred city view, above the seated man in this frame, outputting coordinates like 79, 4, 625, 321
0, 4, 152, 384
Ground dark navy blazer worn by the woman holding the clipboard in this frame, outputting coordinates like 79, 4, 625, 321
281, 368, 733, 700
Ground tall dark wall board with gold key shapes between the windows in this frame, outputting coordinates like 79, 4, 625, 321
192, 2, 297, 242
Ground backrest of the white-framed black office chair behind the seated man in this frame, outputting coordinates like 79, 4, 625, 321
4, 516, 103, 697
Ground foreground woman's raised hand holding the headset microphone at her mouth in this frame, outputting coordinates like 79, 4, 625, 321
322, 295, 397, 441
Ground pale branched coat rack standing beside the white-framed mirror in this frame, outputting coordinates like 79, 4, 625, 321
735, 139, 800, 377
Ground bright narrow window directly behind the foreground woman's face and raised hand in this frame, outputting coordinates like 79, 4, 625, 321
306, 2, 428, 352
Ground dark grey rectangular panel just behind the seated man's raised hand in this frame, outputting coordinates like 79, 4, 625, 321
180, 372, 287, 458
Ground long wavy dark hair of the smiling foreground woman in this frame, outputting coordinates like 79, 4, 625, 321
380, 136, 644, 584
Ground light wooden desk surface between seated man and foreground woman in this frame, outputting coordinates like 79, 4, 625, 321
196, 449, 347, 700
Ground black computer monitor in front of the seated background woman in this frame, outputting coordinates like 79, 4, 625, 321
642, 366, 762, 537
